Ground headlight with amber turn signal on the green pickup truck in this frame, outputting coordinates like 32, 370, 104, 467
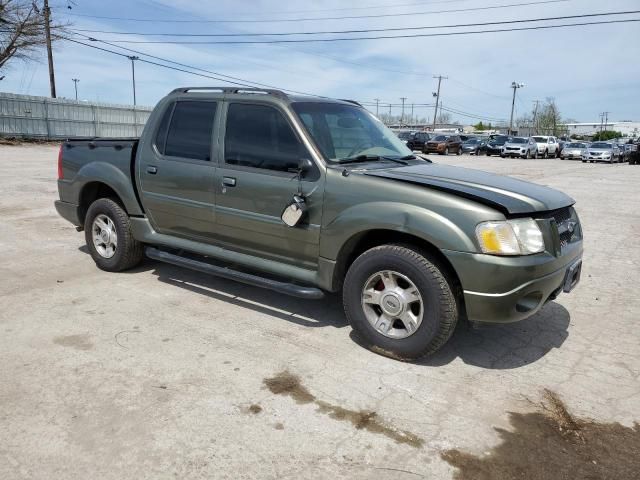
476, 218, 544, 255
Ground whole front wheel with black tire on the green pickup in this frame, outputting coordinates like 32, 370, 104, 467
343, 245, 458, 360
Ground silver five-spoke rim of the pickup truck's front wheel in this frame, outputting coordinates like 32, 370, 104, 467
362, 270, 424, 339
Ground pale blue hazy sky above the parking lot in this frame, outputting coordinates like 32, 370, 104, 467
0, 0, 640, 123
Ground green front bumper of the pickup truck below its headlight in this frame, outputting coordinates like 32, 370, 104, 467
444, 241, 582, 323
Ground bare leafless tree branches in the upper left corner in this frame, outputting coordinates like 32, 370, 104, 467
0, 0, 62, 69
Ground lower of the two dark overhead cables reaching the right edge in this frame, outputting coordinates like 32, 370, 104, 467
79, 14, 640, 45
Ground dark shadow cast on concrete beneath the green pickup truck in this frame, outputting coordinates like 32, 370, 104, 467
80, 248, 570, 370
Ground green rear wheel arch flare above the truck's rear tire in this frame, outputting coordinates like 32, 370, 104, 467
73, 162, 144, 215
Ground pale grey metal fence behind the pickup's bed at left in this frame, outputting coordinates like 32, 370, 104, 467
0, 92, 152, 139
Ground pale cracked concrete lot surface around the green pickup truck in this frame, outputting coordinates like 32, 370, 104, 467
0, 146, 640, 480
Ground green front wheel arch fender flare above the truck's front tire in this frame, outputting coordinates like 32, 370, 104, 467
320, 202, 477, 260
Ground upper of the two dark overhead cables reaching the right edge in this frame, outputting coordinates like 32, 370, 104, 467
69, 7, 640, 37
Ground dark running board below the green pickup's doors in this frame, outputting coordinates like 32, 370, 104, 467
145, 247, 324, 300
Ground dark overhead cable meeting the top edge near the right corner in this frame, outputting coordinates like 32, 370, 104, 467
60, 0, 571, 23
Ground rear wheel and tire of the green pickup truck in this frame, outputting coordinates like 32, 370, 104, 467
84, 198, 144, 272
